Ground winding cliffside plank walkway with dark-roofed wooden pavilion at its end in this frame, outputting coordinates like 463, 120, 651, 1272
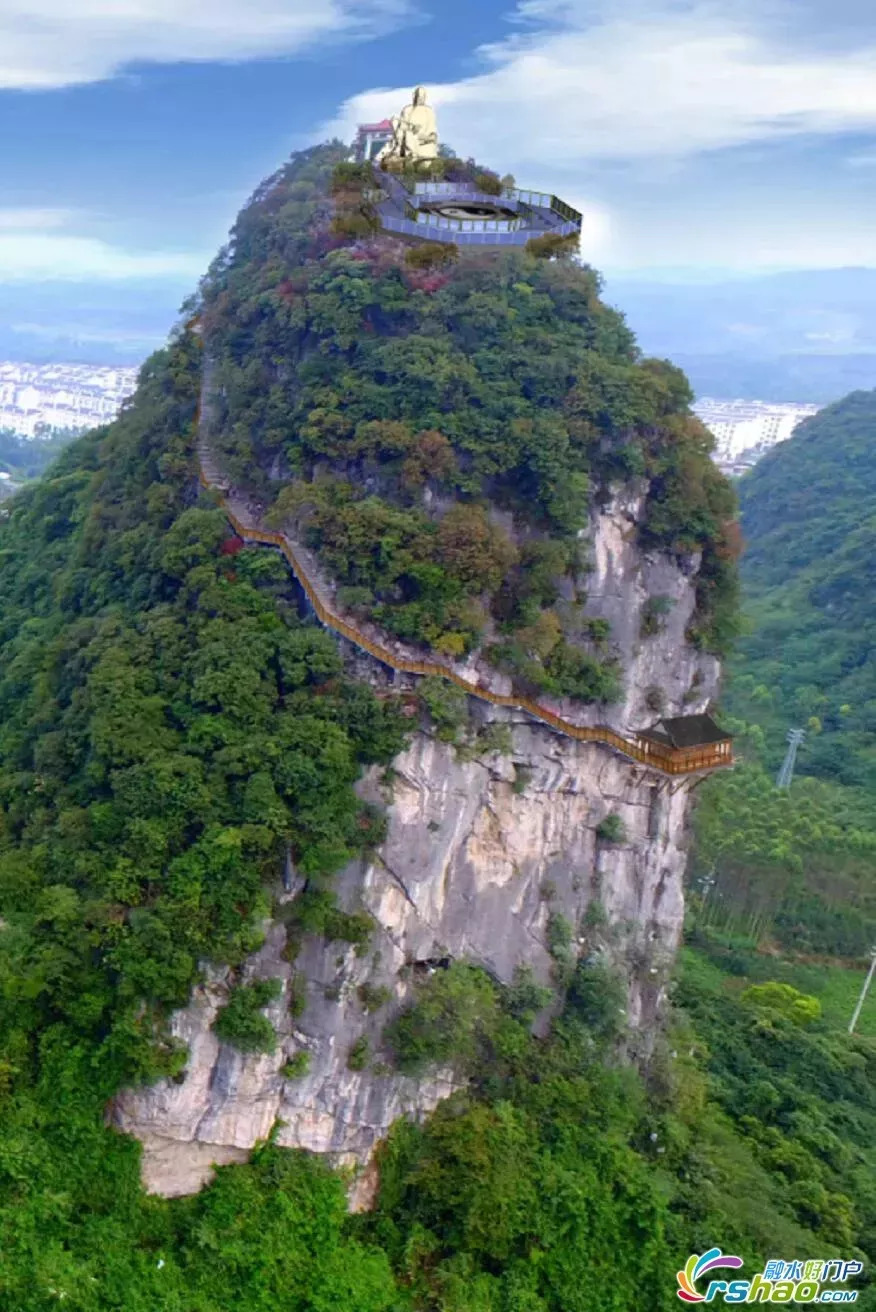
198, 438, 733, 775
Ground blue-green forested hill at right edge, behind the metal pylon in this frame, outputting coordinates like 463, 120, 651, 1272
727, 392, 876, 795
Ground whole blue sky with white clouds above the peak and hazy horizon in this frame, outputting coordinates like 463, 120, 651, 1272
0, 0, 876, 351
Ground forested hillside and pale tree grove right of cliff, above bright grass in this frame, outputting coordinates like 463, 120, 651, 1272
692, 392, 876, 962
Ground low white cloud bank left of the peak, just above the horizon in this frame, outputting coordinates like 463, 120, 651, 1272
0, 209, 209, 282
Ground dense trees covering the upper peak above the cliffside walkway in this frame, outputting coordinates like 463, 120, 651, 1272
201, 147, 734, 701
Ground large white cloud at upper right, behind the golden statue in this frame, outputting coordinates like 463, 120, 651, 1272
326, 0, 876, 166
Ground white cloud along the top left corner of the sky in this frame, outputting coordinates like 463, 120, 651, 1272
0, 0, 407, 91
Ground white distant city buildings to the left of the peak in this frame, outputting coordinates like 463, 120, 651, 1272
0, 361, 138, 438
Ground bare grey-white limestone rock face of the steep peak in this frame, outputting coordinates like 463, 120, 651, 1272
111, 496, 717, 1204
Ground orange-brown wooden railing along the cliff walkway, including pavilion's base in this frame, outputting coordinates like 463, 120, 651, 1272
199, 461, 733, 774
